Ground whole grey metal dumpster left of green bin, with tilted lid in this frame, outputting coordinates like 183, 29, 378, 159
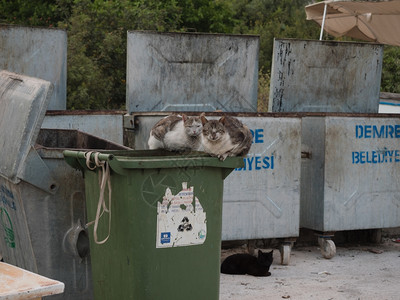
0, 71, 126, 300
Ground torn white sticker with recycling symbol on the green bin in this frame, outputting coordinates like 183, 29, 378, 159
156, 182, 207, 248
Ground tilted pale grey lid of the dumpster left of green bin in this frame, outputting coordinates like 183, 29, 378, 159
0, 71, 53, 183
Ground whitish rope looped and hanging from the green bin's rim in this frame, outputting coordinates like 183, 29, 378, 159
85, 151, 112, 245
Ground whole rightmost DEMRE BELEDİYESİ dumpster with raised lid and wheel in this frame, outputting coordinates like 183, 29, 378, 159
269, 39, 399, 258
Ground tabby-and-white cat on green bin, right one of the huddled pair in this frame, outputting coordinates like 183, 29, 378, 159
200, 113, 253, 160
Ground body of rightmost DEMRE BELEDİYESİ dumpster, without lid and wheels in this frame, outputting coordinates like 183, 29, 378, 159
300, 115, 400, 231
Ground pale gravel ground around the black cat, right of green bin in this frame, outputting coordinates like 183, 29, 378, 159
220, 239, 400, 300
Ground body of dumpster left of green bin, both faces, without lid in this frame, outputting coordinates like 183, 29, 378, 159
0, 161, 93, 300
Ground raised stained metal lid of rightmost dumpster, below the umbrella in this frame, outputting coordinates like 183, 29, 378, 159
269, 39, 383, 113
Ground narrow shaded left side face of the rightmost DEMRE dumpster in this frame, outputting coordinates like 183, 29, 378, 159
300, 117, 325, 231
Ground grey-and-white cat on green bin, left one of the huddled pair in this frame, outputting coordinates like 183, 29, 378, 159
148, 114, 202, 151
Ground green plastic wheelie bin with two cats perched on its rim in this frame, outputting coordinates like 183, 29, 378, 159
64, 150, 243, 300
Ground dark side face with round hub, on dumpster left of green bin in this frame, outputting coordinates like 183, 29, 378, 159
21, 158, 93, 300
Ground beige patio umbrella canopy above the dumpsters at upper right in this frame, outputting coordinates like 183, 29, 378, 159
305, 0, 400, 46
